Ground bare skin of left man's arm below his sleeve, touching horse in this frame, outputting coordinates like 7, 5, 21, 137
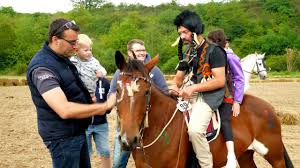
42, 87, 115, 119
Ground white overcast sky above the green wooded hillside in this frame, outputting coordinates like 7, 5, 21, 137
0, 0, 222, 13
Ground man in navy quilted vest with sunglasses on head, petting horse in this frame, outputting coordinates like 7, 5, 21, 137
27, 19, 116, 168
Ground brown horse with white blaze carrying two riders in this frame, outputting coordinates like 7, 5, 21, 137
115, 51, 292, 168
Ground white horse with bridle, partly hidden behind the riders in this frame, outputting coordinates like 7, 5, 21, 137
241, 53, 267, 92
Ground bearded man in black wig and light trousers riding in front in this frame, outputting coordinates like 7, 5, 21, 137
173, 10, 226, 168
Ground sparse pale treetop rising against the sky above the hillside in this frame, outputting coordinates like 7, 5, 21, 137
71, 0, 106, 10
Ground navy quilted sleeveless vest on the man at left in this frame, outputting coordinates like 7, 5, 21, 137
27, 42, 92, 141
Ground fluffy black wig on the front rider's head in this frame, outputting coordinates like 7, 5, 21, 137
174, 10, 204, 35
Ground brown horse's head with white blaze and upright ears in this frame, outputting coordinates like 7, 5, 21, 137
115, 51, 159, 150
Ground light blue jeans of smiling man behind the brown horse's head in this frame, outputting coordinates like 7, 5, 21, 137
112, 129, 131, 168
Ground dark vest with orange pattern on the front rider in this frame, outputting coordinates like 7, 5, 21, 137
190, 42, 227, 110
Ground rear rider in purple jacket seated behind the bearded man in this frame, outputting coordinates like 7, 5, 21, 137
207, 30, 245, 168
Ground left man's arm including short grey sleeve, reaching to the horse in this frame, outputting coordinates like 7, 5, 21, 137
31, 67, 115, 119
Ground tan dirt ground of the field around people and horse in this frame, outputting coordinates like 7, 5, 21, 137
0, 82, 300, 168
